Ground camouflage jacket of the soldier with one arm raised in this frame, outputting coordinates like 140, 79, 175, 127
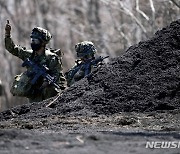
5, 37, 66, 92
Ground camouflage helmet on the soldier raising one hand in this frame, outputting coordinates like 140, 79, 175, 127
30, 27, 52, 44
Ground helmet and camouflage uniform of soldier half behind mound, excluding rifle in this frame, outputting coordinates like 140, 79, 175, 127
65, 41, 97, 86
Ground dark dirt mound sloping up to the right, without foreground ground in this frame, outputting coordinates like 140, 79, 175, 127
0, 20, 180, 119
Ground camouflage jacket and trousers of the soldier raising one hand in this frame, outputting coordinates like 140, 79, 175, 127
5, 25, 66, 102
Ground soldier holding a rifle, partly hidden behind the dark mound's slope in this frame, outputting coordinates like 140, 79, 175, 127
65, 41, 107, 86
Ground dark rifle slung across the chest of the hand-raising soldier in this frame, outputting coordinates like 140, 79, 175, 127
22, 58, 61, 89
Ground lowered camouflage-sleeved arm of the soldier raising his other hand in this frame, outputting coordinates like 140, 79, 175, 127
49, 56, 66, 89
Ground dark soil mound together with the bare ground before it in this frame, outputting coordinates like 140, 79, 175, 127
0, 20, 180, 154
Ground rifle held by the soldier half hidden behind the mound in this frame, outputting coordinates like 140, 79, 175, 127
65, 56, 109, 79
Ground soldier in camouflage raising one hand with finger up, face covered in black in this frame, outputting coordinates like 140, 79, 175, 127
5, 20, 66, 102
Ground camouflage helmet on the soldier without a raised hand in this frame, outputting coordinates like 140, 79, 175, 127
75, 41, 97, 57
